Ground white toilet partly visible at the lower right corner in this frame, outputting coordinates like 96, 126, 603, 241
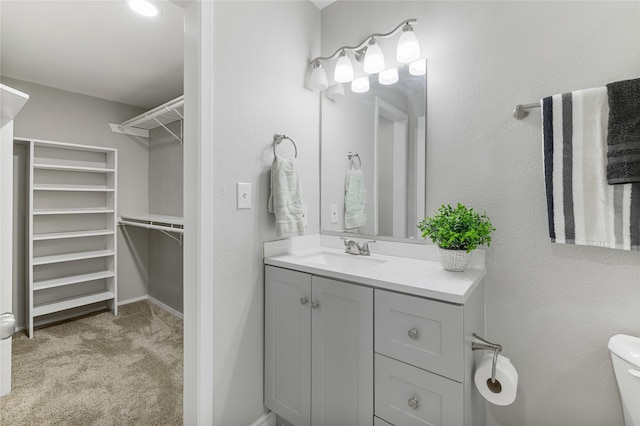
609, 334, 640, 426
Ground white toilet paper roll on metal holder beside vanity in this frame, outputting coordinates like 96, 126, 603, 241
474, 353, 518, 405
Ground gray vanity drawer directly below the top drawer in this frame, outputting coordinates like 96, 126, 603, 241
375, 354, 464, 426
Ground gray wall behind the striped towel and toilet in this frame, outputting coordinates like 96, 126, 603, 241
322, 1, 640, 426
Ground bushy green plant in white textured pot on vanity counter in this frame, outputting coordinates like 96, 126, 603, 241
418, 203, 495, 272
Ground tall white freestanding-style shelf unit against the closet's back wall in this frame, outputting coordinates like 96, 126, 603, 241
22, 138, 117, 337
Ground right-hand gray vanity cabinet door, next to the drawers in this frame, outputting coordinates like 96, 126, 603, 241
311, 276, 373, 426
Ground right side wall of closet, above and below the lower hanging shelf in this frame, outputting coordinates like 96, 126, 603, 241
149, 121, 182, 312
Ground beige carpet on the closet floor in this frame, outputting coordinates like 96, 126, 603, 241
0, 302, 183, 426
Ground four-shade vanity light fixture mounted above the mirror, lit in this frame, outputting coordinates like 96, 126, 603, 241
309, 18, 420, 91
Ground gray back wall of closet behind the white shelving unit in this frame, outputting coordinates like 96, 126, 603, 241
2, 77, 149, 324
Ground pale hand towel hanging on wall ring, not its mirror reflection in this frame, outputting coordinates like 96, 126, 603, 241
268, 155, 304, 237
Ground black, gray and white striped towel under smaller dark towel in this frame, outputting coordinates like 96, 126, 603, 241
540, 87, 640, 250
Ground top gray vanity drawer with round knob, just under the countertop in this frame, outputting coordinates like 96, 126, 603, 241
375, 290, 464, 382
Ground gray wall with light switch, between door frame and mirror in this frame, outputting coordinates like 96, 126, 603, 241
210, 1, 320, 426
